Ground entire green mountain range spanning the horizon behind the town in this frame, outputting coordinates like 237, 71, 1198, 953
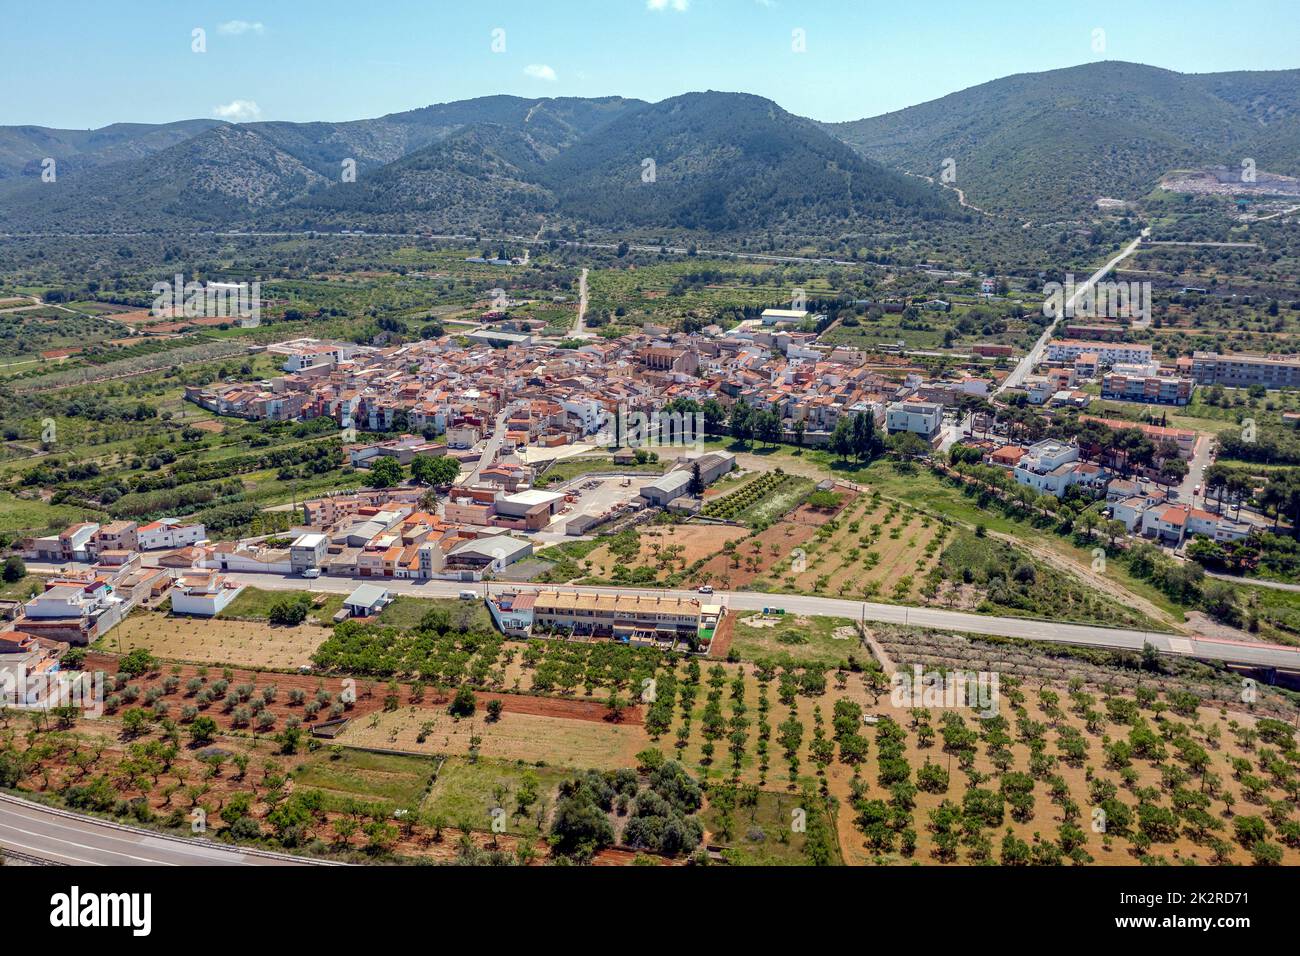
0, 62, 1300, 234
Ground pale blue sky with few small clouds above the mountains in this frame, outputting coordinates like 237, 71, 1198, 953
10, 0, 1300, 127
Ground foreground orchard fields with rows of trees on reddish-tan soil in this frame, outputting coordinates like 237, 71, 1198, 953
0, 590, 1300, 864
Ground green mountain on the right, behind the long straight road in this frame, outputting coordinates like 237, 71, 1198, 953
826, 62, 1300, 216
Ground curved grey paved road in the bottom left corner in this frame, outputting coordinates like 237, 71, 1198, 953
0, 795, 316, 866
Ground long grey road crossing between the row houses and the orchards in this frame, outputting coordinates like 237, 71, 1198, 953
208, 572, 1300, 671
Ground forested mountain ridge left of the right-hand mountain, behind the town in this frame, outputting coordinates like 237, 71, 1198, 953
0, 92, 956, 232
